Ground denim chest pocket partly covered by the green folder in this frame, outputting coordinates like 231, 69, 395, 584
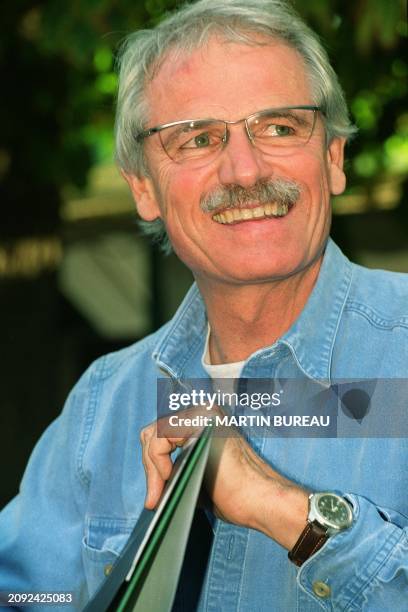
82, 516, 136, 597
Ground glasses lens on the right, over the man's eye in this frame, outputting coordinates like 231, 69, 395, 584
248, 108, 316, 154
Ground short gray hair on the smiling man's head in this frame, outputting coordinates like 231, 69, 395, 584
115, 0, 356, 252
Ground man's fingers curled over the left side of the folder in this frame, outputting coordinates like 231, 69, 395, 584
140, 423, 185, 510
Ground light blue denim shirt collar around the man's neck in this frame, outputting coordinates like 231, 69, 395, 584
153, 239, 353, 385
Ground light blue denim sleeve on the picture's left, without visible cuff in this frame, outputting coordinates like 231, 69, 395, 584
0, 366, 96, 611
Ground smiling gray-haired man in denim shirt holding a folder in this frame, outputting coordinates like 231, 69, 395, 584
0, 0, 408, 612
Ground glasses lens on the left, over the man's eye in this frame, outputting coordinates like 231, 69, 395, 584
159, 121, 226, 163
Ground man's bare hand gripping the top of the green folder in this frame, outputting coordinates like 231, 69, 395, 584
140, 422, 308, 550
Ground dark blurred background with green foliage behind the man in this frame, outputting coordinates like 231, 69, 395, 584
0, 0, 408, 507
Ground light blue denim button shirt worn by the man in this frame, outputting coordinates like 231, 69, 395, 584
0, 240, 408, 612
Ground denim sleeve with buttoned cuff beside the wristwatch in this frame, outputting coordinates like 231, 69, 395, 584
297, 495, 408, 612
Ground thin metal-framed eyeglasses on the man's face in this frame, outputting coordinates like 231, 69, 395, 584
135, 106, 321, 167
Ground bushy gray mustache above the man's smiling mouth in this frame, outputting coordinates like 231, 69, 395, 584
200, 178, 301, 212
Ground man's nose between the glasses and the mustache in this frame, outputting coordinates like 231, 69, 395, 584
218, 125, 271, 187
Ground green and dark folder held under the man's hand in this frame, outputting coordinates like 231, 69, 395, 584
84, 427, 211, 612
